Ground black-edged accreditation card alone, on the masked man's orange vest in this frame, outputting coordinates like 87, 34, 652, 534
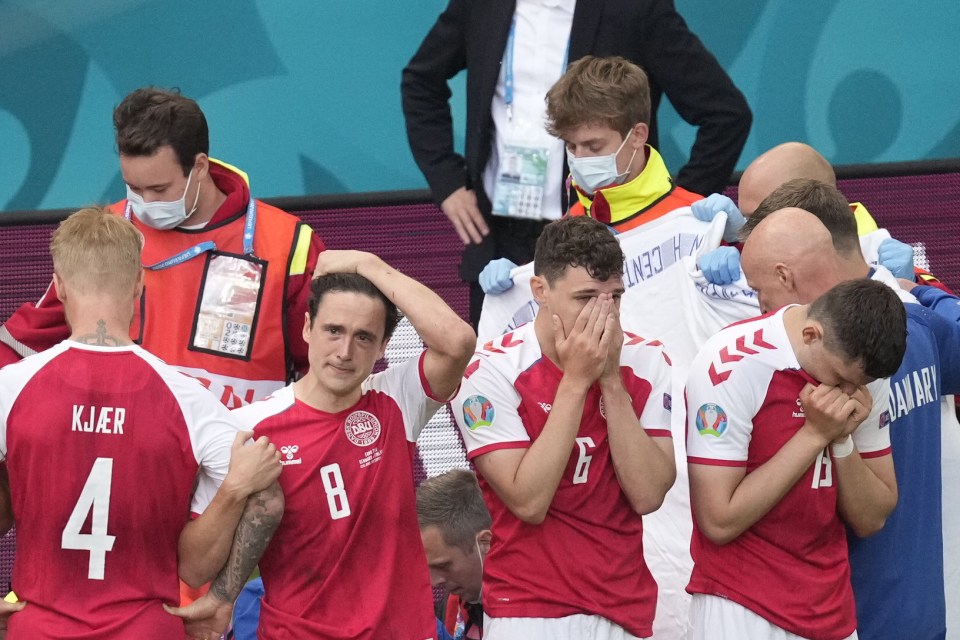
190, 251, 267, 360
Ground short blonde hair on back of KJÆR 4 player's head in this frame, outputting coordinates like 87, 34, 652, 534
50, 207, 143, 295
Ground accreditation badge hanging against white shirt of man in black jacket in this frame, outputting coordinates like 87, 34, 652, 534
493, 144, 550, 220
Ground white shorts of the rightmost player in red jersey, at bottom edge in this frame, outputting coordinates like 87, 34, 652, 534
690, 593, 857, 640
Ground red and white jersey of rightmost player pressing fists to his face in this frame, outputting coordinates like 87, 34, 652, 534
686, 310, 890, 639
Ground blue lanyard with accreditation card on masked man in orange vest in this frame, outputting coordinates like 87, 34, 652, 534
124, 196, 267, 360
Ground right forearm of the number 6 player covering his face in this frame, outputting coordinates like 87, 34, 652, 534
601, 384, 677, 515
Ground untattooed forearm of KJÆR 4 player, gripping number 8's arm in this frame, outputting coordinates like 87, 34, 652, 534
177, 485, 247, 588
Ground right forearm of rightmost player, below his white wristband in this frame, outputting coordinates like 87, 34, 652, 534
833, 450, 897, 538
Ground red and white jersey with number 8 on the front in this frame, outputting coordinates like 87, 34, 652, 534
234, 356, 441, 640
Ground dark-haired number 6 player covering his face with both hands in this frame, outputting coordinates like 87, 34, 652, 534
452, 216, 676, 640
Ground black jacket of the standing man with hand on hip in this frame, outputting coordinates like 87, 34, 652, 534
401, 0, 751, 272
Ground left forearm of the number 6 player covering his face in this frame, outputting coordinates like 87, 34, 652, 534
501, 378, 587, 524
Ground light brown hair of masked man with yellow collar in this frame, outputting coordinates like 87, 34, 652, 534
547, 56, 650, 138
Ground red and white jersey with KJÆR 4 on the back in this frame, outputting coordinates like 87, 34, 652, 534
0, 341, 237, 640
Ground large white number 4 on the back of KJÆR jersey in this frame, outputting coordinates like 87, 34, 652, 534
60, 458, 116, 580
